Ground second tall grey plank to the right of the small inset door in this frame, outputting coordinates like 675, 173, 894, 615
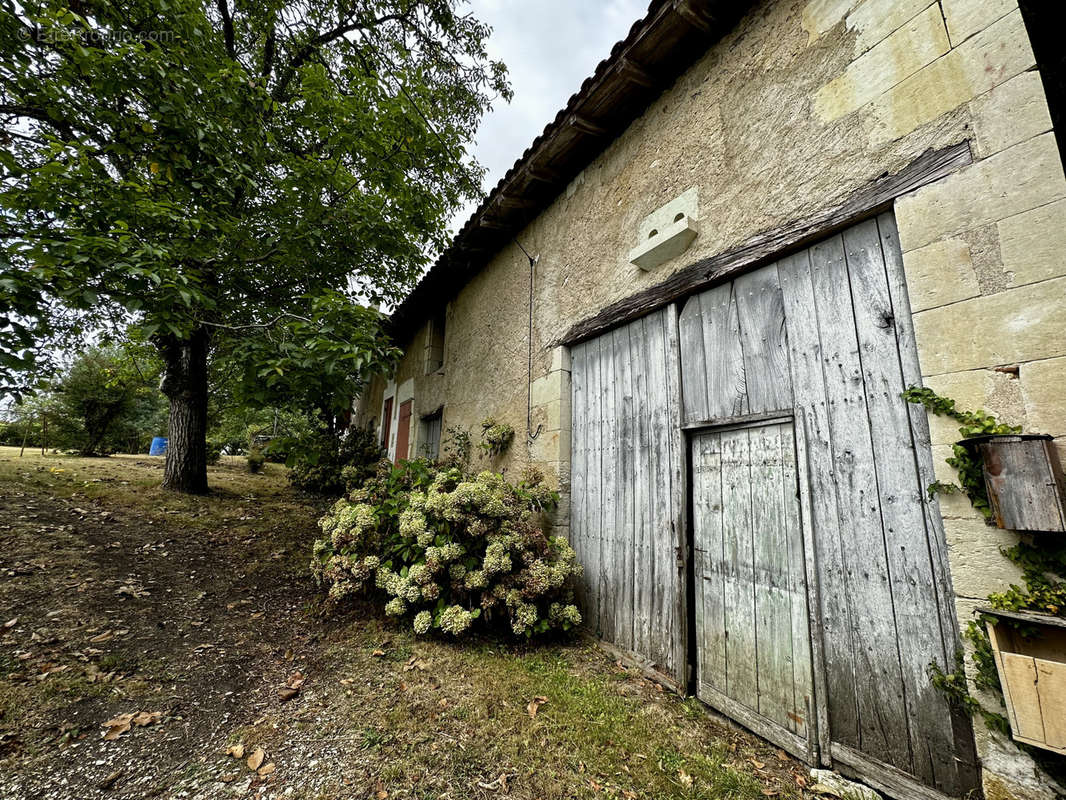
810, 236, 912, 772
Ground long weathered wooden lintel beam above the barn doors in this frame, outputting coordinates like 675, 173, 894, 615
552, 141, 973, 346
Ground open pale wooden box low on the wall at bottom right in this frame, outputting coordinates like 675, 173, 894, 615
981, 608, 1066, 754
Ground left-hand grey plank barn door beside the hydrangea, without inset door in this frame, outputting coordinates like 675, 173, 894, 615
570, 307, 687, 687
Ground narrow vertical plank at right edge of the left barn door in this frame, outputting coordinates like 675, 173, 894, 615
663, 304, 691, 686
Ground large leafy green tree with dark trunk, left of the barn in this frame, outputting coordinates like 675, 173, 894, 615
0, 0, 508, 491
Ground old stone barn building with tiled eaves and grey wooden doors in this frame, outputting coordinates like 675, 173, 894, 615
356, 0, 1066, 798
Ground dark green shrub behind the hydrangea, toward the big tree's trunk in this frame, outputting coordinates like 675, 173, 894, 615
287, 428, 385, 497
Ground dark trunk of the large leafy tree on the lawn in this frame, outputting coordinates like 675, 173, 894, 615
159, 329, 209, 495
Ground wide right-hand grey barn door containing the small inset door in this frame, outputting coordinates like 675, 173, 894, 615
680, 213, 976, 797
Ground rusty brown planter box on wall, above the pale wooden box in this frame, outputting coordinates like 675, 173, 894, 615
958, 434, 1066, 533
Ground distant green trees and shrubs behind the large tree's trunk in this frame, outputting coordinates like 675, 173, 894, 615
0, 325, 381, 486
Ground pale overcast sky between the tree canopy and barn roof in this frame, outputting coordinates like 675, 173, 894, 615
452, 0, 648, 229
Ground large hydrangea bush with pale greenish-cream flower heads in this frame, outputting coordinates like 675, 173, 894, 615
311, 461, 581, 637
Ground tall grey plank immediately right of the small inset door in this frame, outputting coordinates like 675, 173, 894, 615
778, 251, 868, 753
